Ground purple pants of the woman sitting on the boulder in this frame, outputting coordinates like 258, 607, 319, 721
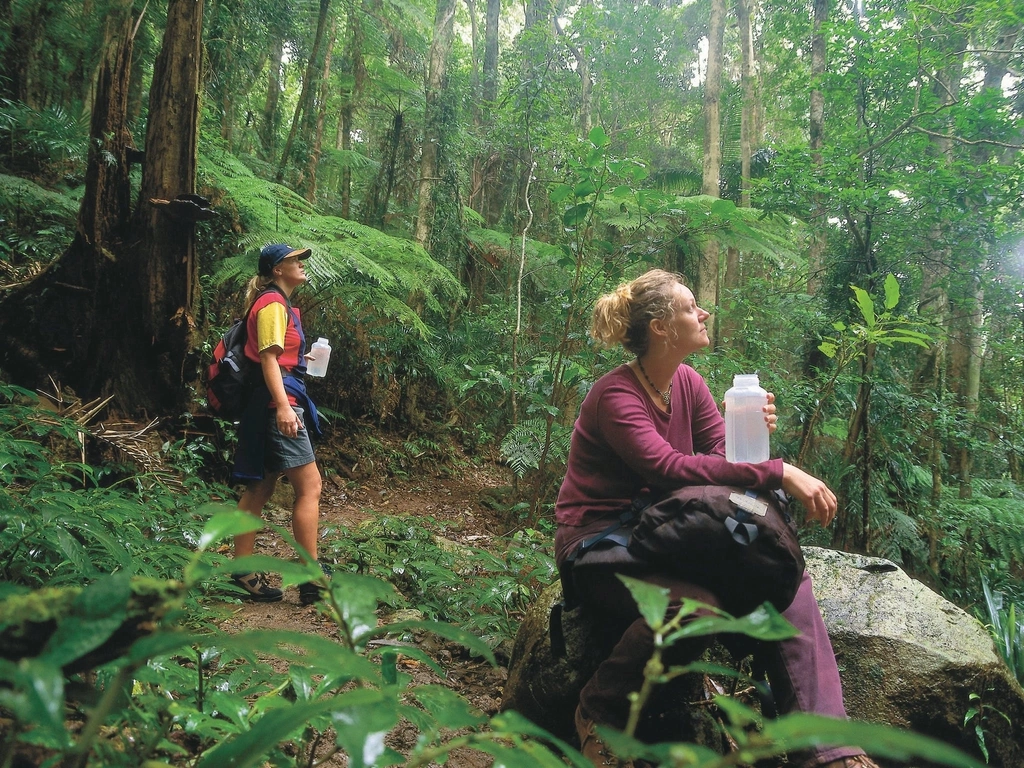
575, 567, 864, 767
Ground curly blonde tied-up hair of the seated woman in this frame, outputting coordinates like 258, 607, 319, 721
590, 269, 685, 357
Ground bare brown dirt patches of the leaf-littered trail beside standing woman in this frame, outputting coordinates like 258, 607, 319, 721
212, 457, 524, 768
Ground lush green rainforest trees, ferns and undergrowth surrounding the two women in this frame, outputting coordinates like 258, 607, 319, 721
0, 0, 1024, 768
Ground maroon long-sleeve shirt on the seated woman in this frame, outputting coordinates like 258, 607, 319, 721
555, 365, 782, 563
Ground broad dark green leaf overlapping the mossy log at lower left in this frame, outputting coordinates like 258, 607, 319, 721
41, 573, 131, 667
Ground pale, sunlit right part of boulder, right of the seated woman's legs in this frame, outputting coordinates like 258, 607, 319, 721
804, 547, 1024, 768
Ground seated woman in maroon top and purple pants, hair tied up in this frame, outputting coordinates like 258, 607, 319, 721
555, 269, 878, 768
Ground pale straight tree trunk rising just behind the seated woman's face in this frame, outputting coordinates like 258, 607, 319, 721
696, 0, 725, 347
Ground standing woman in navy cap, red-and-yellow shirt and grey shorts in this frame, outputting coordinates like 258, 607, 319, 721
231, 244, 330, 605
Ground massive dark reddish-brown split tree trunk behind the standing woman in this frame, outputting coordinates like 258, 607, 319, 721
0, 0, 203, 413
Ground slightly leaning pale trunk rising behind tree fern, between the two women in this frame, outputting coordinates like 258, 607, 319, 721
415, 0, 456, 248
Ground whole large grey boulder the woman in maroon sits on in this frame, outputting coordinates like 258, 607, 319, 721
502, 548, 1024, 768
